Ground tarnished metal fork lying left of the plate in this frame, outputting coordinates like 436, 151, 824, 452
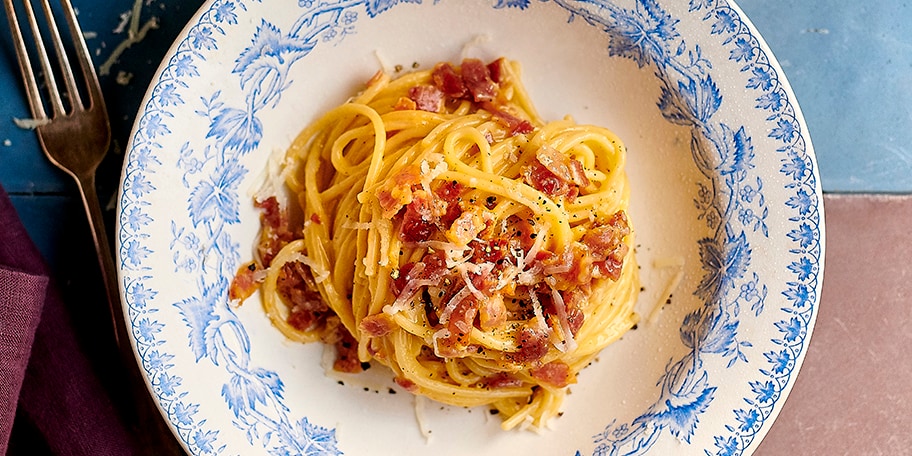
3, 0, 125, 345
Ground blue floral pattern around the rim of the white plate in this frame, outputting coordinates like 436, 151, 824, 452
117, 0, 824, 455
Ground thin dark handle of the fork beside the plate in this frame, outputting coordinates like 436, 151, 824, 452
76, 172, 126, 349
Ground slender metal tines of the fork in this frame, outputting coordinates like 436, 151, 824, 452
3, 0, 101, 121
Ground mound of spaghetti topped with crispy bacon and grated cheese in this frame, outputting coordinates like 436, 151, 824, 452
229, 59, 639, 429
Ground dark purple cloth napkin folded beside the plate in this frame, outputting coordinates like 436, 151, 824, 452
0, 186, 137, 455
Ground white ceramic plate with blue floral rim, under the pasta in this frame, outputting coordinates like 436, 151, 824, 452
117, 0, 824, 455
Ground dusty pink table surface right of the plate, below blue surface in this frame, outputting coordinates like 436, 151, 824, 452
755, 195, 912, 456
